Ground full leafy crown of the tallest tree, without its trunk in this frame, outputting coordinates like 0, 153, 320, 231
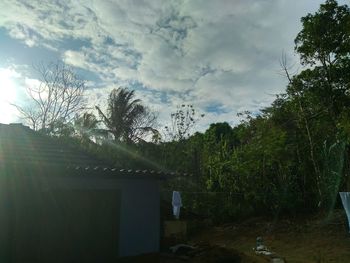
295, 0, 350, 119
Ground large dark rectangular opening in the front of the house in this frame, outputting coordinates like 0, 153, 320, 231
40, 189, 120, 262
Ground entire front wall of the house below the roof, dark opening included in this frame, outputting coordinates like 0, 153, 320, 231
0, 173, 160, 262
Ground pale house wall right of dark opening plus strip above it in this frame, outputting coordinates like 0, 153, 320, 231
50, 177, 160, 257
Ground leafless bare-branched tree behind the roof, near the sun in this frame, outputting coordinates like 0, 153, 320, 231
14, 62, 86, 130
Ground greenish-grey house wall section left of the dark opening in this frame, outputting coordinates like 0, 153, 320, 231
0, 169, 43, 262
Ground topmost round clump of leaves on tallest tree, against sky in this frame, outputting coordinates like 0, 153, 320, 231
295, 0, 350, 65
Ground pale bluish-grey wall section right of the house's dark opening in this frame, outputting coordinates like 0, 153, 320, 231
119, 179, 160, 257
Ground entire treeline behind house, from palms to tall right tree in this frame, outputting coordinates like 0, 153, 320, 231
17, 0, 350, 221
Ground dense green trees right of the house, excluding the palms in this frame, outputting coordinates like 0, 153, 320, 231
155, 0, 350, 221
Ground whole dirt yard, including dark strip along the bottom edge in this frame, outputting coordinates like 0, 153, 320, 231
122, 210, 350, 263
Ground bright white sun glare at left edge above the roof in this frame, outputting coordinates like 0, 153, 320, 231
0, 68, 19, 123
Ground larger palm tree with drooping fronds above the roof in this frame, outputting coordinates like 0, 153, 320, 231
96, 88, 158, 143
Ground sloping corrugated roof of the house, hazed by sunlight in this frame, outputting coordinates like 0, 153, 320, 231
0, 124, 189, 178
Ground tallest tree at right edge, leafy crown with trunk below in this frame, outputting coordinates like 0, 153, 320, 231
292, 0, 350, 206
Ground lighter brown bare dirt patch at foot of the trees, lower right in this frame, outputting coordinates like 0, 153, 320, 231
191, 210, 350, 263
